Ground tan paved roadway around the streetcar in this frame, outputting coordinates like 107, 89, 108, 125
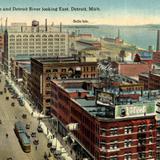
0, 74, 54, 160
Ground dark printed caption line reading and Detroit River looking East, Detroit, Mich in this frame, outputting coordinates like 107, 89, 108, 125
0, 6, 100, 12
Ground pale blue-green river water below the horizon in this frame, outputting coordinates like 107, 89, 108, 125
64, 25, 159, 49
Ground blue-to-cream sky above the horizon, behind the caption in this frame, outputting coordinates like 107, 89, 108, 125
0, 0, 160, 25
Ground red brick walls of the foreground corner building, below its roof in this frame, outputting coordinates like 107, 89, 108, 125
51, 81, 156, 160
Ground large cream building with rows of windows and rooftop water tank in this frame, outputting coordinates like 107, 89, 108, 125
3, 21, 68, 71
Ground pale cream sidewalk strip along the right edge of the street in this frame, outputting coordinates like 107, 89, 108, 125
3, 73, 72, 160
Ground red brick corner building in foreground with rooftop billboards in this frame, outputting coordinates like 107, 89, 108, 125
51, 80, 156, 160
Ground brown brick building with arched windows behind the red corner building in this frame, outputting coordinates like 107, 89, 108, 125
30, 56, 98, 111
